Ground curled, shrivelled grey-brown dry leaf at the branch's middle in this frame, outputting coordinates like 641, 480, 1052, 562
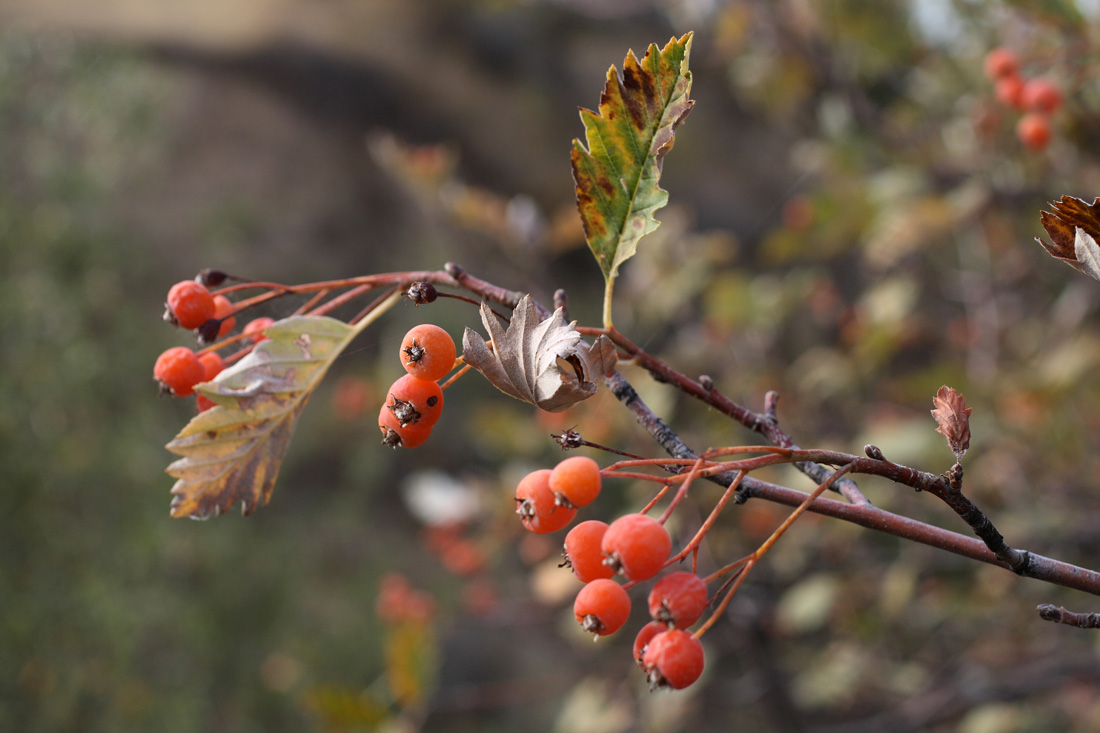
462, 295, 617, 413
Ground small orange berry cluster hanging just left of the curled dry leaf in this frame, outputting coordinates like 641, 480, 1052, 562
378, 324, 455, 448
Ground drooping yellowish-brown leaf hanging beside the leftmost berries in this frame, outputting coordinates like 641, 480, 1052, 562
165, 294, 399, 512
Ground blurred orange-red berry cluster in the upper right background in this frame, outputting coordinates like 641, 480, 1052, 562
985, 47, 1062, 151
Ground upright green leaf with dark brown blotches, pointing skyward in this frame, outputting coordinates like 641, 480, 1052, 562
572, 33, 695, 288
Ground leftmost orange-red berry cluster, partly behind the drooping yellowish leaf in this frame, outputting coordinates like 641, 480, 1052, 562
153, 277, 275, 412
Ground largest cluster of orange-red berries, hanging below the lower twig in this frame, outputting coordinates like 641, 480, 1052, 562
515, 457, 708, 690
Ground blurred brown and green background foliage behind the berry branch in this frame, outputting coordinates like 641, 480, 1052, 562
0, 0, 1100, 733
